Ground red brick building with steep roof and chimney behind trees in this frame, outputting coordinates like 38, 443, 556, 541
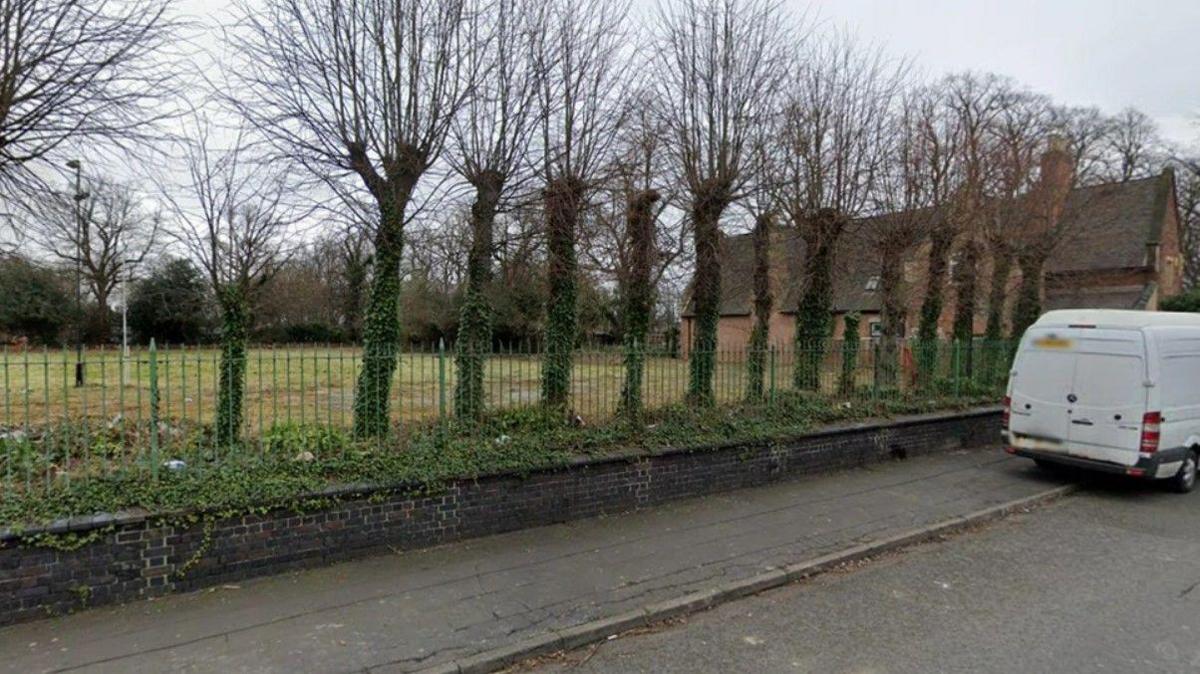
680, 142, 1183, 349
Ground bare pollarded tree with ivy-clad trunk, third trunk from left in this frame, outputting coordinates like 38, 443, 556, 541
446, 0, 546, 419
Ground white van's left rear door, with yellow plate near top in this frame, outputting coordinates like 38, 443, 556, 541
1009, 327, 1075, 451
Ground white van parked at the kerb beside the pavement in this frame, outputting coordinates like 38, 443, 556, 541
1004, 309, 1200, 492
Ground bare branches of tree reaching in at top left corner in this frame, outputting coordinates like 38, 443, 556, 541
0, 0, 180, 199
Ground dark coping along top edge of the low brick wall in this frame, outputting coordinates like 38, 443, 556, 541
0, 405, 1001, 543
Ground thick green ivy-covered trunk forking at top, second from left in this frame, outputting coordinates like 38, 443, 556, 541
354, 174, 419, 438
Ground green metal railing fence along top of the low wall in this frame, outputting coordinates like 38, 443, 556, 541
0, 341, 1012, 489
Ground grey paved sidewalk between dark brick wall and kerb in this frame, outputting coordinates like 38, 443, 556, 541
0, 450, 1070, 673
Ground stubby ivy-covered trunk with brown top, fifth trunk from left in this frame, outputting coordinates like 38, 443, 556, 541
620, 189, 659, 420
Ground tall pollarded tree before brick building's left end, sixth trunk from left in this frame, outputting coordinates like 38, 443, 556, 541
654, 0, 799, 404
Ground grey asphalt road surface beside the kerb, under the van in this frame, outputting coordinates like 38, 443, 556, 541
523, 477, 1200, 674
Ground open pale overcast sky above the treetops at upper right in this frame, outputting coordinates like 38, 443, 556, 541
801, 0, 1200, 143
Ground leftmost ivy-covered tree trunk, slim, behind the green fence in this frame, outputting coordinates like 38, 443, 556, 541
215, 285, 250, 446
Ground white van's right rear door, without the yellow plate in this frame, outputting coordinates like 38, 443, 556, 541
1067, 329, 1147, 465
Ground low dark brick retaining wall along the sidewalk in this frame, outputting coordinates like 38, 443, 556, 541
0, 402, 1000, 625
